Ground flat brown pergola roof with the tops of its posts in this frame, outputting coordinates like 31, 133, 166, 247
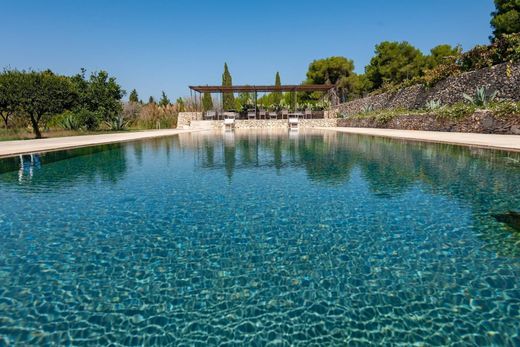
189, 84, 334, 109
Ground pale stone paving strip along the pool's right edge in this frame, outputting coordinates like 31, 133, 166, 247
317, 127, 520, 152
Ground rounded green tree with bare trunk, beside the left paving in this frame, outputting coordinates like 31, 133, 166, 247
10, 71, 77, 139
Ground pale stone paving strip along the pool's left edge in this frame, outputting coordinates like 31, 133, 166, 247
0, 129, 199, 158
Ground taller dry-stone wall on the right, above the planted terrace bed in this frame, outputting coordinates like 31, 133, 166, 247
331, 63, 520, 115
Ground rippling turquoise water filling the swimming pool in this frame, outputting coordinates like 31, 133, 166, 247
0, 132, 520, 346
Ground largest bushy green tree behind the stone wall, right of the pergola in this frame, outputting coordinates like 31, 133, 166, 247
365, 41, 425, 89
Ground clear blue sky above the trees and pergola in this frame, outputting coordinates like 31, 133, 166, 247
0, 0, 494, 100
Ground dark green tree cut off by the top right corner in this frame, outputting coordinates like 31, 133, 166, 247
491, 0, 520, 38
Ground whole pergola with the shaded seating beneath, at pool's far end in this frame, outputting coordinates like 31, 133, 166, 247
189, 84, 335, 120
